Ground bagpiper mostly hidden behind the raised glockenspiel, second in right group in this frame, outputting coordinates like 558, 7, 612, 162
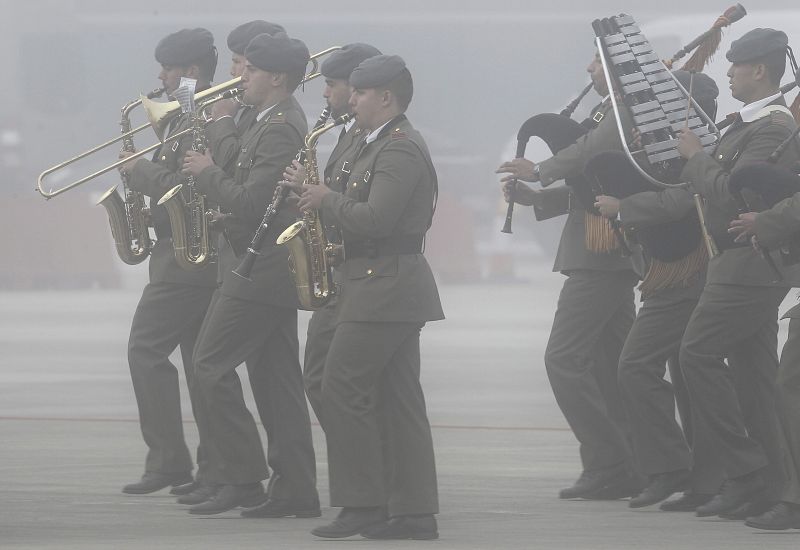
595, 71, 723, 511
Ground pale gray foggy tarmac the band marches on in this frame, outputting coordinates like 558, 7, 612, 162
0, 282, 800, 550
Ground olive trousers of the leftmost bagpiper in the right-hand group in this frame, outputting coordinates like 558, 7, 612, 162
544, 270, 637, 471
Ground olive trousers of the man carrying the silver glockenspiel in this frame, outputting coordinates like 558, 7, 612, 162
680, 284, 788, 500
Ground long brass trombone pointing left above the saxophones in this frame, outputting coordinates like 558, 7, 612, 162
36, 46, 341, 200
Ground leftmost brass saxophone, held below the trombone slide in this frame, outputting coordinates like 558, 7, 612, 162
97, 88, 164, 265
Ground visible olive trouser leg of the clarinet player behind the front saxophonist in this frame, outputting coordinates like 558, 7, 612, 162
303, 298, 336, 430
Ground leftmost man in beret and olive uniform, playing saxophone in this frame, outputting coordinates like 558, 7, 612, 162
120, 28, 217, 494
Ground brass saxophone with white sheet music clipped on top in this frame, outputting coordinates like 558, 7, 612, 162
158, 82, 216, 271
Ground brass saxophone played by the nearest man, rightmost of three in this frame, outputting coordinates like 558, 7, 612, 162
277, 115, 351, 309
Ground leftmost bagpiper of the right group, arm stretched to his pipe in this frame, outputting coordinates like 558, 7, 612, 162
497, 50, 641, 498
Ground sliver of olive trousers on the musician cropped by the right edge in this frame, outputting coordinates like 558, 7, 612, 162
777, 318, 800, 504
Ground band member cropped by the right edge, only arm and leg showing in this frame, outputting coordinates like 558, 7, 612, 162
731, 154, 800, 530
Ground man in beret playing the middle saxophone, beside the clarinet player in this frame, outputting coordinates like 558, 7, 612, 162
184, 33, 320, 517
